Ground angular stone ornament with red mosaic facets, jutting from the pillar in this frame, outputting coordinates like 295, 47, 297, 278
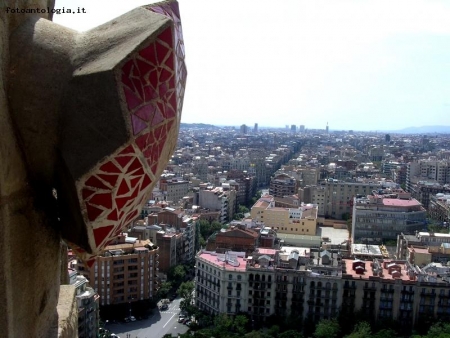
10, 2, 186, 264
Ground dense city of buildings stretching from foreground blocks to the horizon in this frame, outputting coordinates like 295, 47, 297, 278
69, 123, 450, 337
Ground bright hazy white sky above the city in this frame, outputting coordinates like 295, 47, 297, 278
54, 0, 450, 130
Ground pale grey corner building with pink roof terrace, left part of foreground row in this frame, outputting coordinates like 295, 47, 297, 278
196, 247, 341, 321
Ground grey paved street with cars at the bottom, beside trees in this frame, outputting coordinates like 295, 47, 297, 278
106, 298, 188, 338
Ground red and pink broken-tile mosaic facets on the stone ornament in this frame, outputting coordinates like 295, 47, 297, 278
73, 2, 186, 265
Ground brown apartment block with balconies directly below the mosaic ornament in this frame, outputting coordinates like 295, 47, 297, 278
77, 234, 159, 305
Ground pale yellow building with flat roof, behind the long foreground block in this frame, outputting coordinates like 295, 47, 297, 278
250, 195, 318, 236
